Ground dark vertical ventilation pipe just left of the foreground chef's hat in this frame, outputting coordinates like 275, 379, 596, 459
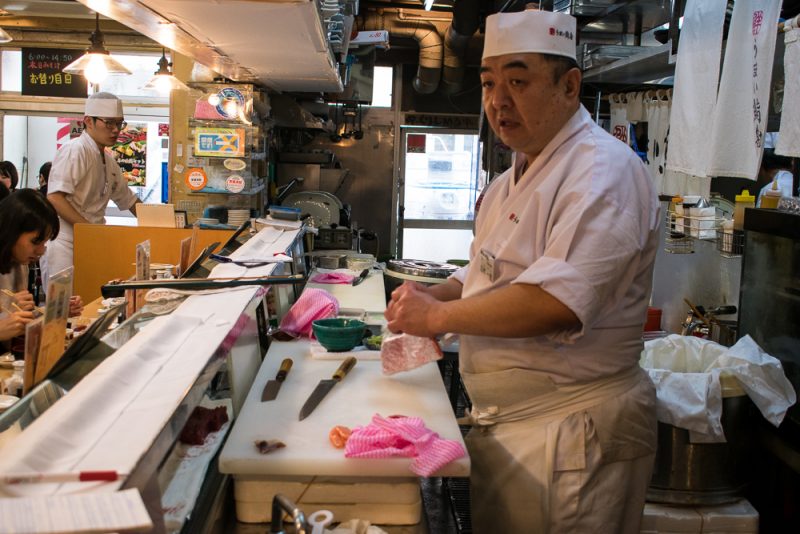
442, 0, 480, 95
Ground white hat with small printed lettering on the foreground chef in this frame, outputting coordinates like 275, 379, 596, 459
483, 9, 577, 59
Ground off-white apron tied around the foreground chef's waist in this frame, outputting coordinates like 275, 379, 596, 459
462, 366, 657, 534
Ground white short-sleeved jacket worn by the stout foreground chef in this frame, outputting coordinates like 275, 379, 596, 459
454, 106, 660, 384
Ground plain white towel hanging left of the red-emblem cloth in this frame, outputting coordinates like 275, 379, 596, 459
667, 0, 728, 178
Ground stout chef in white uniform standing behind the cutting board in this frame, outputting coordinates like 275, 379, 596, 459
386, 11, 660, 533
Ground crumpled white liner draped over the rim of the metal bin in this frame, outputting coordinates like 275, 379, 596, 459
640, 334, 797, 443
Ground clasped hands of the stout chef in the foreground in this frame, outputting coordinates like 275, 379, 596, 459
383, 282, 441, 337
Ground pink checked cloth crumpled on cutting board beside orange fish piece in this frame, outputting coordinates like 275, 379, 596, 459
344, 414, 467, 477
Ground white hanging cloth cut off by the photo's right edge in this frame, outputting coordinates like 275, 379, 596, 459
775, 28, 800, 158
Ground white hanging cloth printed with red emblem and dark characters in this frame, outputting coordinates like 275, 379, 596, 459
698, 0, 781, 180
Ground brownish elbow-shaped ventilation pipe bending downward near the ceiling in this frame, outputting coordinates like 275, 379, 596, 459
363, 13, 444, 94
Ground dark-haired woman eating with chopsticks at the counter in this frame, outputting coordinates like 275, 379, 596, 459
0, 189, 83, 348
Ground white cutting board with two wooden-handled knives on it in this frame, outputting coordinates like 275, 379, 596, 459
219, 338, 470, 477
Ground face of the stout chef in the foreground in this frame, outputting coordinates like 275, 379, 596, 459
481, 53, 581, 162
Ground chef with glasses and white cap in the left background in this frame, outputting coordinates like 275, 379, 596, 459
41, 92, 139, 291
